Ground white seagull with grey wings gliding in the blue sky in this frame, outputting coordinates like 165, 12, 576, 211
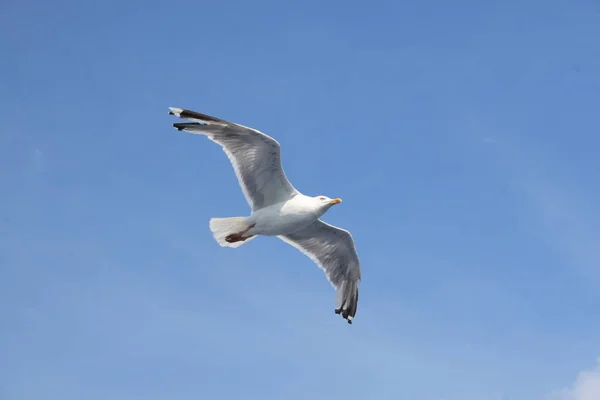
169, 107, 361, 324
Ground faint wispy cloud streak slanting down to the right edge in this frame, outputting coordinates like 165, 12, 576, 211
468, 115, 600, 282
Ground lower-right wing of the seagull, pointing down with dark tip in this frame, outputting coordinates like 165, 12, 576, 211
279, 220, 360, 323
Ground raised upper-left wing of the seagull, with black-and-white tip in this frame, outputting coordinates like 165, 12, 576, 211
169, 107, 298, 211
